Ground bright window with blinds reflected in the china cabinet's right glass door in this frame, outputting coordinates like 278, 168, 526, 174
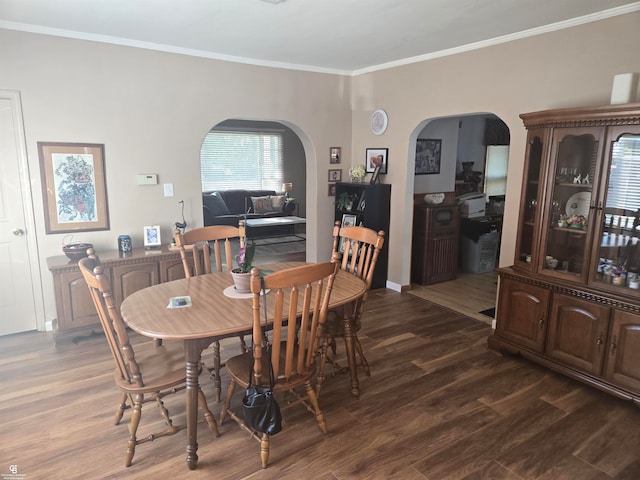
606, 135, 640, 211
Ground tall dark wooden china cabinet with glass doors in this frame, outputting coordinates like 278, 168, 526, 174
488, 104, 640, 404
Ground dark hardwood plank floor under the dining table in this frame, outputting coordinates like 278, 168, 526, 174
0, 290, 640, 480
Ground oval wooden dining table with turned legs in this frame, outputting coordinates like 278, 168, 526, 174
120, 262, 366, 470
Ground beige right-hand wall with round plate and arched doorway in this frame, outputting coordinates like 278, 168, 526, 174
352, 12, 640, 287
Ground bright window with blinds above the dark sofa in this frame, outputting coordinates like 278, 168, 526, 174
200, 130, 283, 192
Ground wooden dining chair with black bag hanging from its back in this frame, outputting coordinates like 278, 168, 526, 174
220, 262, 339, 468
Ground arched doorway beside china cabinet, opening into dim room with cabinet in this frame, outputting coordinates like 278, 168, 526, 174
411, 113, 509, 319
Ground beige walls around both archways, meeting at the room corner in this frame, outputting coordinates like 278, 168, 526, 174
0, 13, 640, 327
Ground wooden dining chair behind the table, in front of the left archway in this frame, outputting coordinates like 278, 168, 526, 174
174, 221, 251, 402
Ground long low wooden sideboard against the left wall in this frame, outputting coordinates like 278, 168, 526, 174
47, 246, 190, 342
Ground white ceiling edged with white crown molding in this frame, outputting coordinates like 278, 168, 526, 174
0, 0, 640, 74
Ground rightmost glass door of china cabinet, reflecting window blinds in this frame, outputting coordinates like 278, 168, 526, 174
593, 126, 640, 294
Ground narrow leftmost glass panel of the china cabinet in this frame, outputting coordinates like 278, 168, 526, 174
516, 130, 544, 269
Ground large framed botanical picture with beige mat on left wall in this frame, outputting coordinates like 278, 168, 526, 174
38, 142, 109, 234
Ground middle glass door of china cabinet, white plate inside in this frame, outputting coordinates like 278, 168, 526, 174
538, 128, 603, 282
